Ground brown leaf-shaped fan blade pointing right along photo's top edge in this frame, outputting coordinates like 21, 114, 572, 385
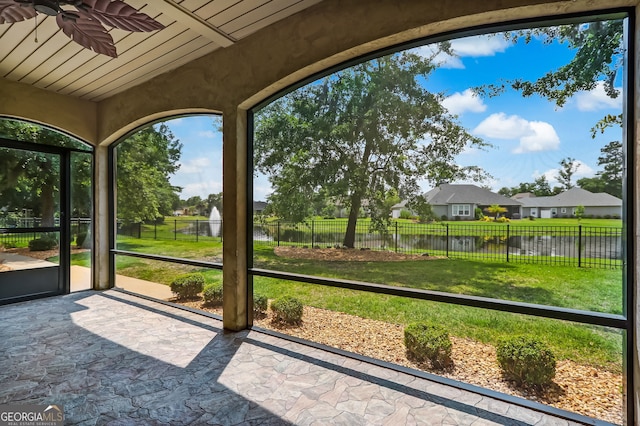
77, 0, 164, 32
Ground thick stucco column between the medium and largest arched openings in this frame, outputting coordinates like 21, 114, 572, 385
222, 109, 249, 331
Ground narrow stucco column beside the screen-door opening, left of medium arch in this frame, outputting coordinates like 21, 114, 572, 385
93, 146, 111, 290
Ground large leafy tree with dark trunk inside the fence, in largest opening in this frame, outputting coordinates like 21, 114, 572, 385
254, 51, 485, 247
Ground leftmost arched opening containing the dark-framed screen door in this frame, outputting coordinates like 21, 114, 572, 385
0, 119, 93, 303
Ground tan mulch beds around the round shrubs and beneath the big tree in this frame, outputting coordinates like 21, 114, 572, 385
178, 247, 623, 424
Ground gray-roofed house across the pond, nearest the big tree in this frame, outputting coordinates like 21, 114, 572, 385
391, 183, 522, 220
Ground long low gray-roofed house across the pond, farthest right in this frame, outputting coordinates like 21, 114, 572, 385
514, 187, 622, 218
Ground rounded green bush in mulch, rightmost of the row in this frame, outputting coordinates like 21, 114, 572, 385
496, 336, 556, 386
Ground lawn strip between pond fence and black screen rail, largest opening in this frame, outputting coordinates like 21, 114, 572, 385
254, 246, 622, 314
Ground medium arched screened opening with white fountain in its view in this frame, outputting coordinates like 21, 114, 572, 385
110, 115, 223, 300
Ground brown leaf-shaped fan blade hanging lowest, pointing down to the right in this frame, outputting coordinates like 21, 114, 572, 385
56, 13, 118, 58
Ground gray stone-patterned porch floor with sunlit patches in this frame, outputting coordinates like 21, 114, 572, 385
0, 290, 592, 426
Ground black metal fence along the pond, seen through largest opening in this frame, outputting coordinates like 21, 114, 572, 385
253, 221, 623, 268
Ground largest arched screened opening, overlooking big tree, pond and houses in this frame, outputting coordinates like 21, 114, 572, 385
247, 11, 634, 423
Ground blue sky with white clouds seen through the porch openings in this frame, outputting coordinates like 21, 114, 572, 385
162, 22, 622, 200
